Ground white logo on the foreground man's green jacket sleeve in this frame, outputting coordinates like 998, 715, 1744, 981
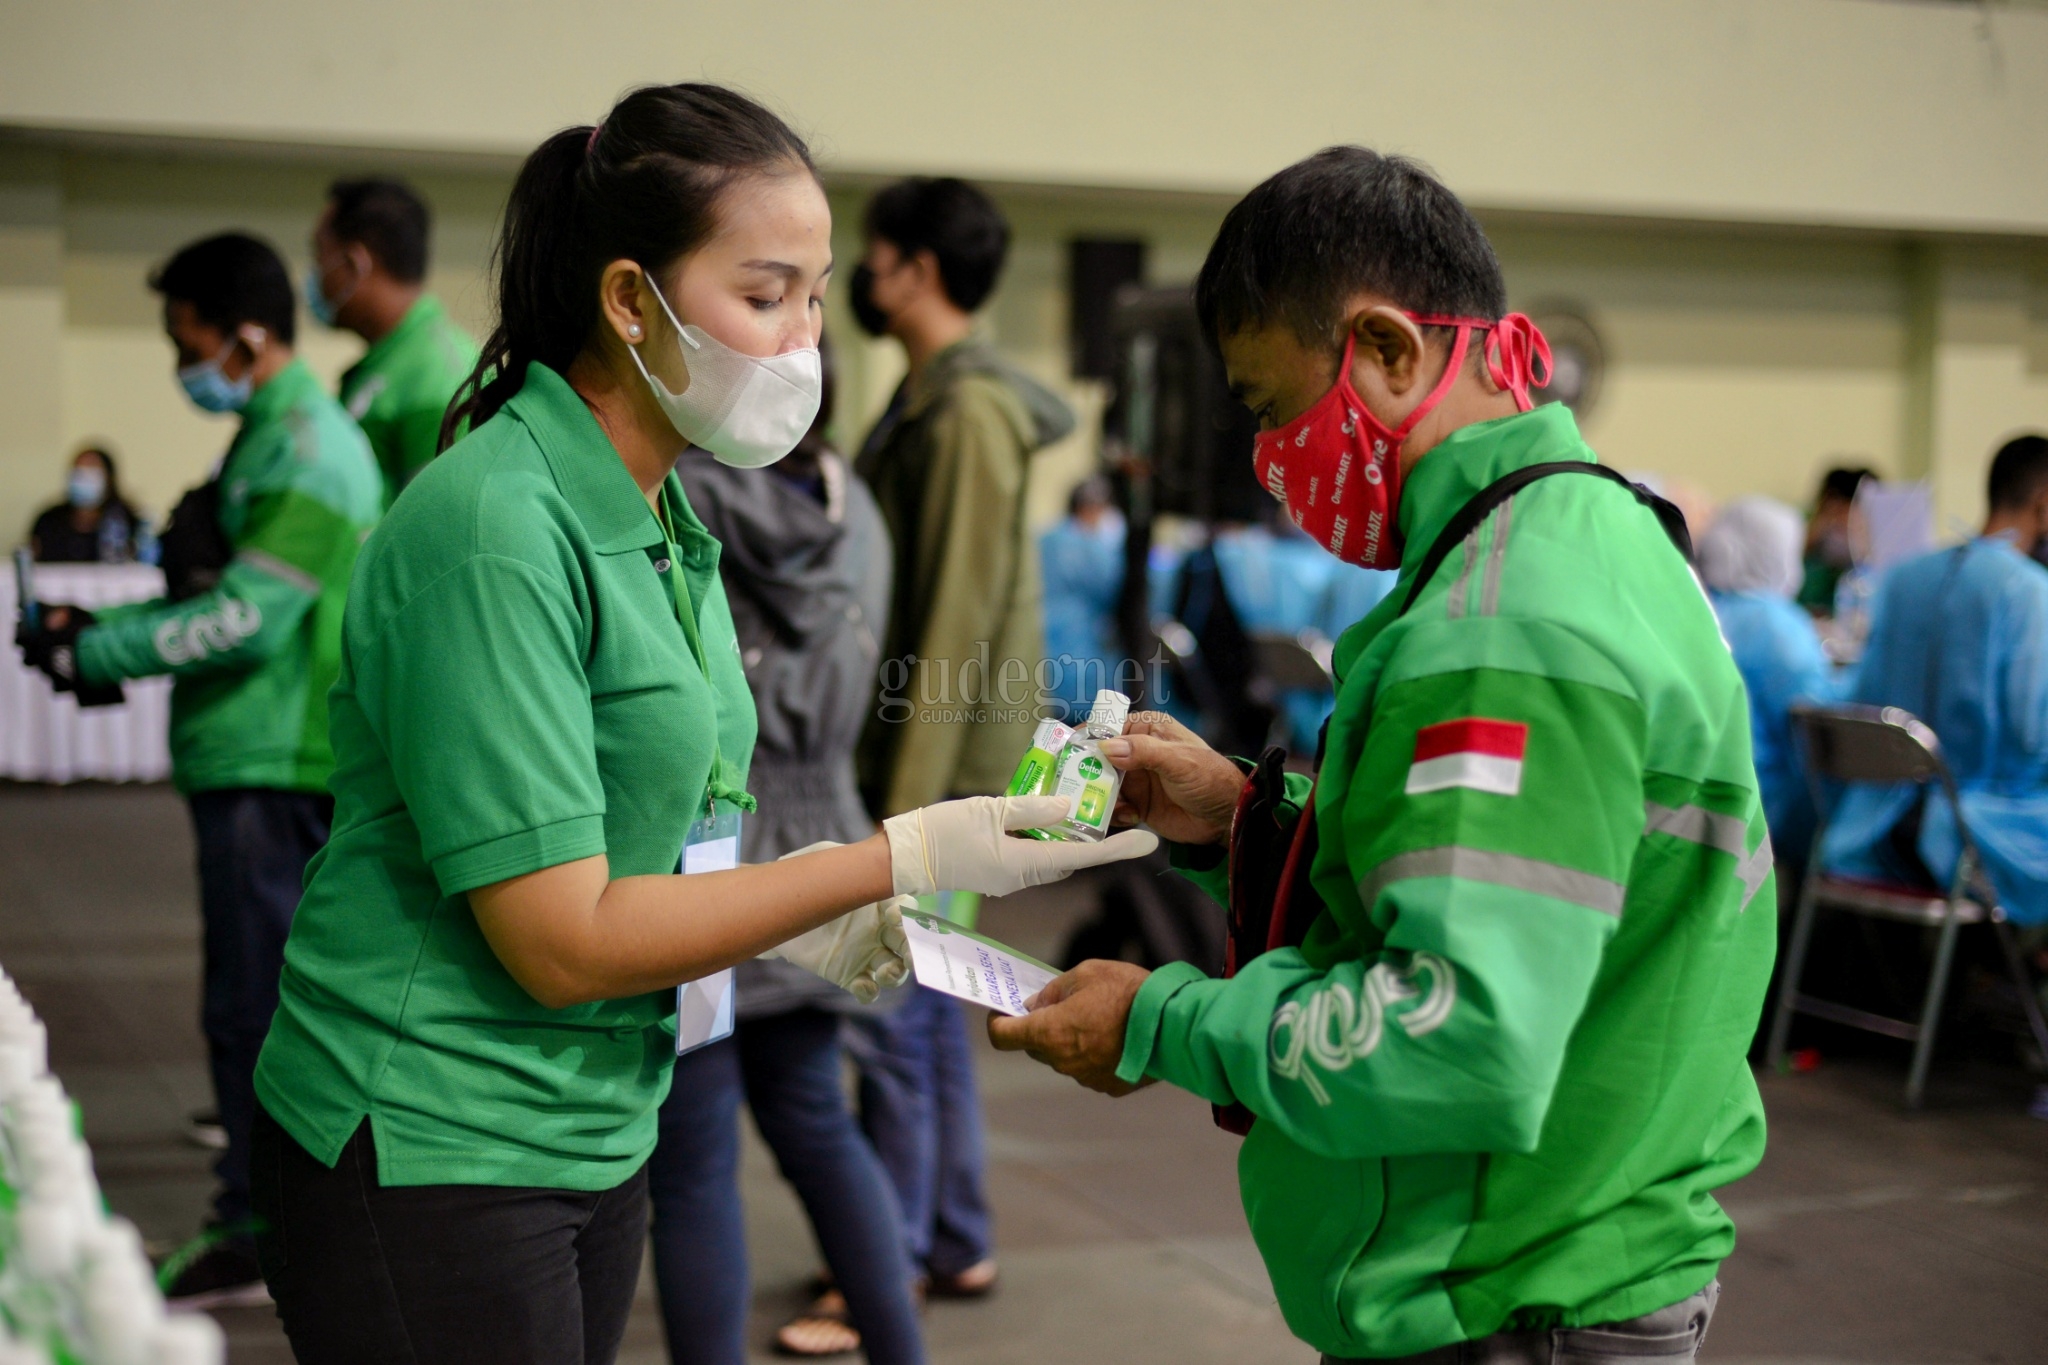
1266, 954, 1458, 1105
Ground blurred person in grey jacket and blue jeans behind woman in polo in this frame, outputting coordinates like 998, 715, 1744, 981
647, 340, 924, 1365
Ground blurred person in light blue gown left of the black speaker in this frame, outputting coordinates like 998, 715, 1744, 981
1038, 475, 1128, 716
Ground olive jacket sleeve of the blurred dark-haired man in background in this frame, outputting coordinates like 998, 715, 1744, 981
885, 379, 1026, 810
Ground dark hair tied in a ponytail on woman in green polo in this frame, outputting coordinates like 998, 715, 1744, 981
440, 84, 817, 450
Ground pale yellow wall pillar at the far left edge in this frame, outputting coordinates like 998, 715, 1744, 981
0, 149, 63, 548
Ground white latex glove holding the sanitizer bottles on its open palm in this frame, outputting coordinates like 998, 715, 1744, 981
883, 796, 1159, 896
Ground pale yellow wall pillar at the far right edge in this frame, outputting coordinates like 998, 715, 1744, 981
1905, 244, 2048, 540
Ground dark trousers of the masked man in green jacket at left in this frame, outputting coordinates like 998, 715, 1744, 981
188, 788, 334, 1224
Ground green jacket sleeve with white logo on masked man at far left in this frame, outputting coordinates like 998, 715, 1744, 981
78, 487, 360, 681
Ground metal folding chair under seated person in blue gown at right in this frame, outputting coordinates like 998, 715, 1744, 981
1767, 706, 2048, 1109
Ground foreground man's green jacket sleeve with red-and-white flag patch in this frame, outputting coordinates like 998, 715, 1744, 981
1120, 620, 1645, 1158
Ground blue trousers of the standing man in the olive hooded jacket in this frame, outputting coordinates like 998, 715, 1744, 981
846, 986, 995, 1275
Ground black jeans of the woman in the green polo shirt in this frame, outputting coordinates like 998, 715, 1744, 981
254, 1109, 647, 1365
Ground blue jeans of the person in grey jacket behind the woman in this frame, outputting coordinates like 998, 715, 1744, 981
647, 1009, 924, 1365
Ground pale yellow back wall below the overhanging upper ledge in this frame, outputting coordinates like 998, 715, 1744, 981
0, 145, 2048, 540
